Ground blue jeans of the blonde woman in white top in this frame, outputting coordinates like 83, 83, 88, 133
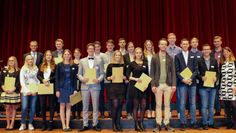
21, 95, 37, 124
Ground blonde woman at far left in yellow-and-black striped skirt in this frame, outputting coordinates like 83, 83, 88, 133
0, 56, 20, 130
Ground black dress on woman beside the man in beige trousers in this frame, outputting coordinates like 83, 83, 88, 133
126, 61, 148, 99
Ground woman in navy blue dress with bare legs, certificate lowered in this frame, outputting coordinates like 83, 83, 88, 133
55, 49, 78, 132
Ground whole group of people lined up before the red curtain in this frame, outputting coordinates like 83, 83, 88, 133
0, 33, 236, 132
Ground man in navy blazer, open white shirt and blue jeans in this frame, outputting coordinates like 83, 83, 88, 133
175, 38, 198, 131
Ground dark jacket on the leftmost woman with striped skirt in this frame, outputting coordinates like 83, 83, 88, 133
0, 69, 20, 93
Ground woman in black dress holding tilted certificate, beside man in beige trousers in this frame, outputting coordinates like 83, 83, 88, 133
126, 47, 148, 131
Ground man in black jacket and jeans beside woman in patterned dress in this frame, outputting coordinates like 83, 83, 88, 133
198, 44, 218, 130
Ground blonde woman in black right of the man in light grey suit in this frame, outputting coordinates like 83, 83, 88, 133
106, 50, 126, 132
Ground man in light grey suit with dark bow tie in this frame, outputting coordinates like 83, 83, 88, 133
78, 43, 104, 131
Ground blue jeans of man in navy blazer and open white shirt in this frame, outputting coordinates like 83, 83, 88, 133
178, 85, 197, 124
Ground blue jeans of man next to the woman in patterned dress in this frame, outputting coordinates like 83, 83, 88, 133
199, 87, 216, 125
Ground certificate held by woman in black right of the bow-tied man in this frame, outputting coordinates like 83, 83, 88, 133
112, 67, 124, 83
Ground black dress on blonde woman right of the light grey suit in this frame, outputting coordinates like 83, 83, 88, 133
106, 64, 125, 99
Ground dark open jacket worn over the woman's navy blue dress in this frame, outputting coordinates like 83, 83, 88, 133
55, 62, 78, 91
